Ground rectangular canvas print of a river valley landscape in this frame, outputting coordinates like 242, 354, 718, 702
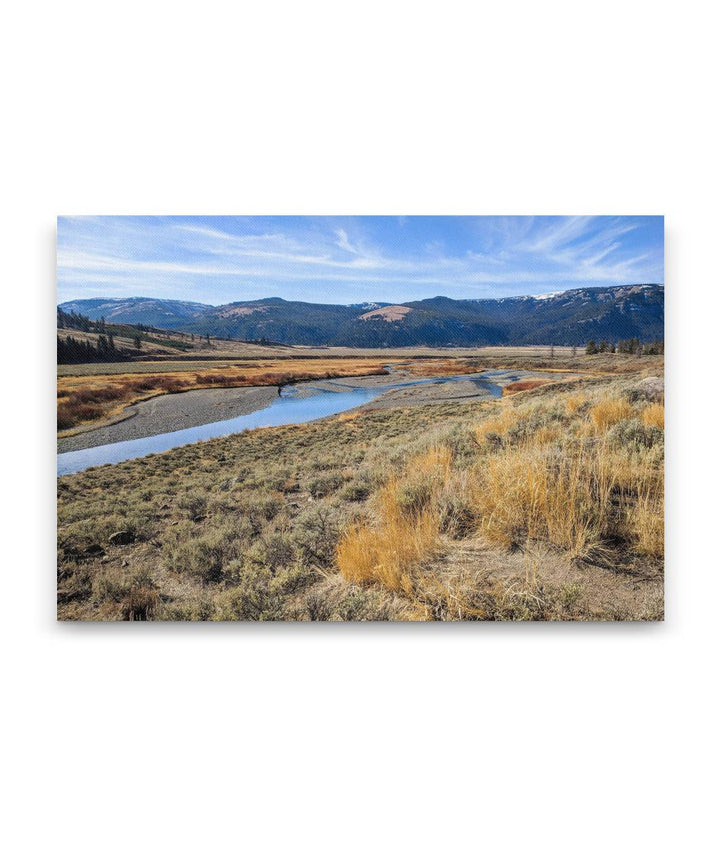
57, 216, 665, 622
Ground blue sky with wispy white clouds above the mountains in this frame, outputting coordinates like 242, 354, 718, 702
57, 216, 664, 305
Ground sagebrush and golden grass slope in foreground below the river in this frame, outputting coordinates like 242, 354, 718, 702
58, 358, 664, 620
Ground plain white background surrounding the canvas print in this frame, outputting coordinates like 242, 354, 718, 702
0, 0, 720, 854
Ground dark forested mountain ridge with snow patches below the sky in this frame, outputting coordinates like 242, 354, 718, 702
60, 283, 665, 348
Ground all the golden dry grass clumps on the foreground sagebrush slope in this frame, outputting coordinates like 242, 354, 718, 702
337, 382, 663, 614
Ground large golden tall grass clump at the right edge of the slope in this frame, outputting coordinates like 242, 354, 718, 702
473, 394, 663, 559
